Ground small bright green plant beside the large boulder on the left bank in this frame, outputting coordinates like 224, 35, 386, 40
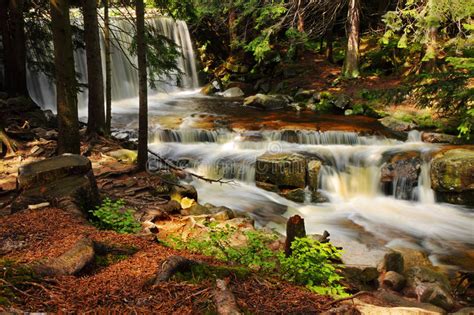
89, 198, 141, 233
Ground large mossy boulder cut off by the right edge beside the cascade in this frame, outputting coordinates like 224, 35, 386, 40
431, 149, 474, 205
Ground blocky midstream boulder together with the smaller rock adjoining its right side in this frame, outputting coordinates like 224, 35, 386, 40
255, 153, 322, 202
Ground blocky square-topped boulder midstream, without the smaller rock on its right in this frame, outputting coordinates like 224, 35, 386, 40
255, 153, 306, 188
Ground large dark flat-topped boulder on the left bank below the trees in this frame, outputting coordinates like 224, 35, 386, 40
12, 154, 99, 214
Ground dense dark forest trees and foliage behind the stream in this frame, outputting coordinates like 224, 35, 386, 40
0, 0, 474, 163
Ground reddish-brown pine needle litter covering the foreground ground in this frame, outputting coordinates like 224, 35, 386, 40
0, 208, 332, 314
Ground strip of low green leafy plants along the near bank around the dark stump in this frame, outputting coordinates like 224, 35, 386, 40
165, 223, 346, 296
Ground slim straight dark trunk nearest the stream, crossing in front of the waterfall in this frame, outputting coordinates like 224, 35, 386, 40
135, 0, 148, 170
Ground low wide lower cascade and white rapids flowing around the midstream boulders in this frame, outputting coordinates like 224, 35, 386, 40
150, 128, 474, 264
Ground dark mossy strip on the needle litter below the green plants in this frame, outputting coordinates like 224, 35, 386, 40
174, 264, 250, 283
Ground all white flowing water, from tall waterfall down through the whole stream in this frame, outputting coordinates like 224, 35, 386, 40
28, 17, 474, 269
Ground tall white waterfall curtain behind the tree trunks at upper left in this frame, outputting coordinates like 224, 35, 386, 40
27, 16, 199, 114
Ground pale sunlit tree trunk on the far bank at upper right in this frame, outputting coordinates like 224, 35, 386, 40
342, 0, 360, 78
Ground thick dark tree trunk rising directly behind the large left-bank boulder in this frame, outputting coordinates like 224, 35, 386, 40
50, 0, 80, 154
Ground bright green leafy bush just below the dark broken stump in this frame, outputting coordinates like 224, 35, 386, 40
279, 237, 347, 296
